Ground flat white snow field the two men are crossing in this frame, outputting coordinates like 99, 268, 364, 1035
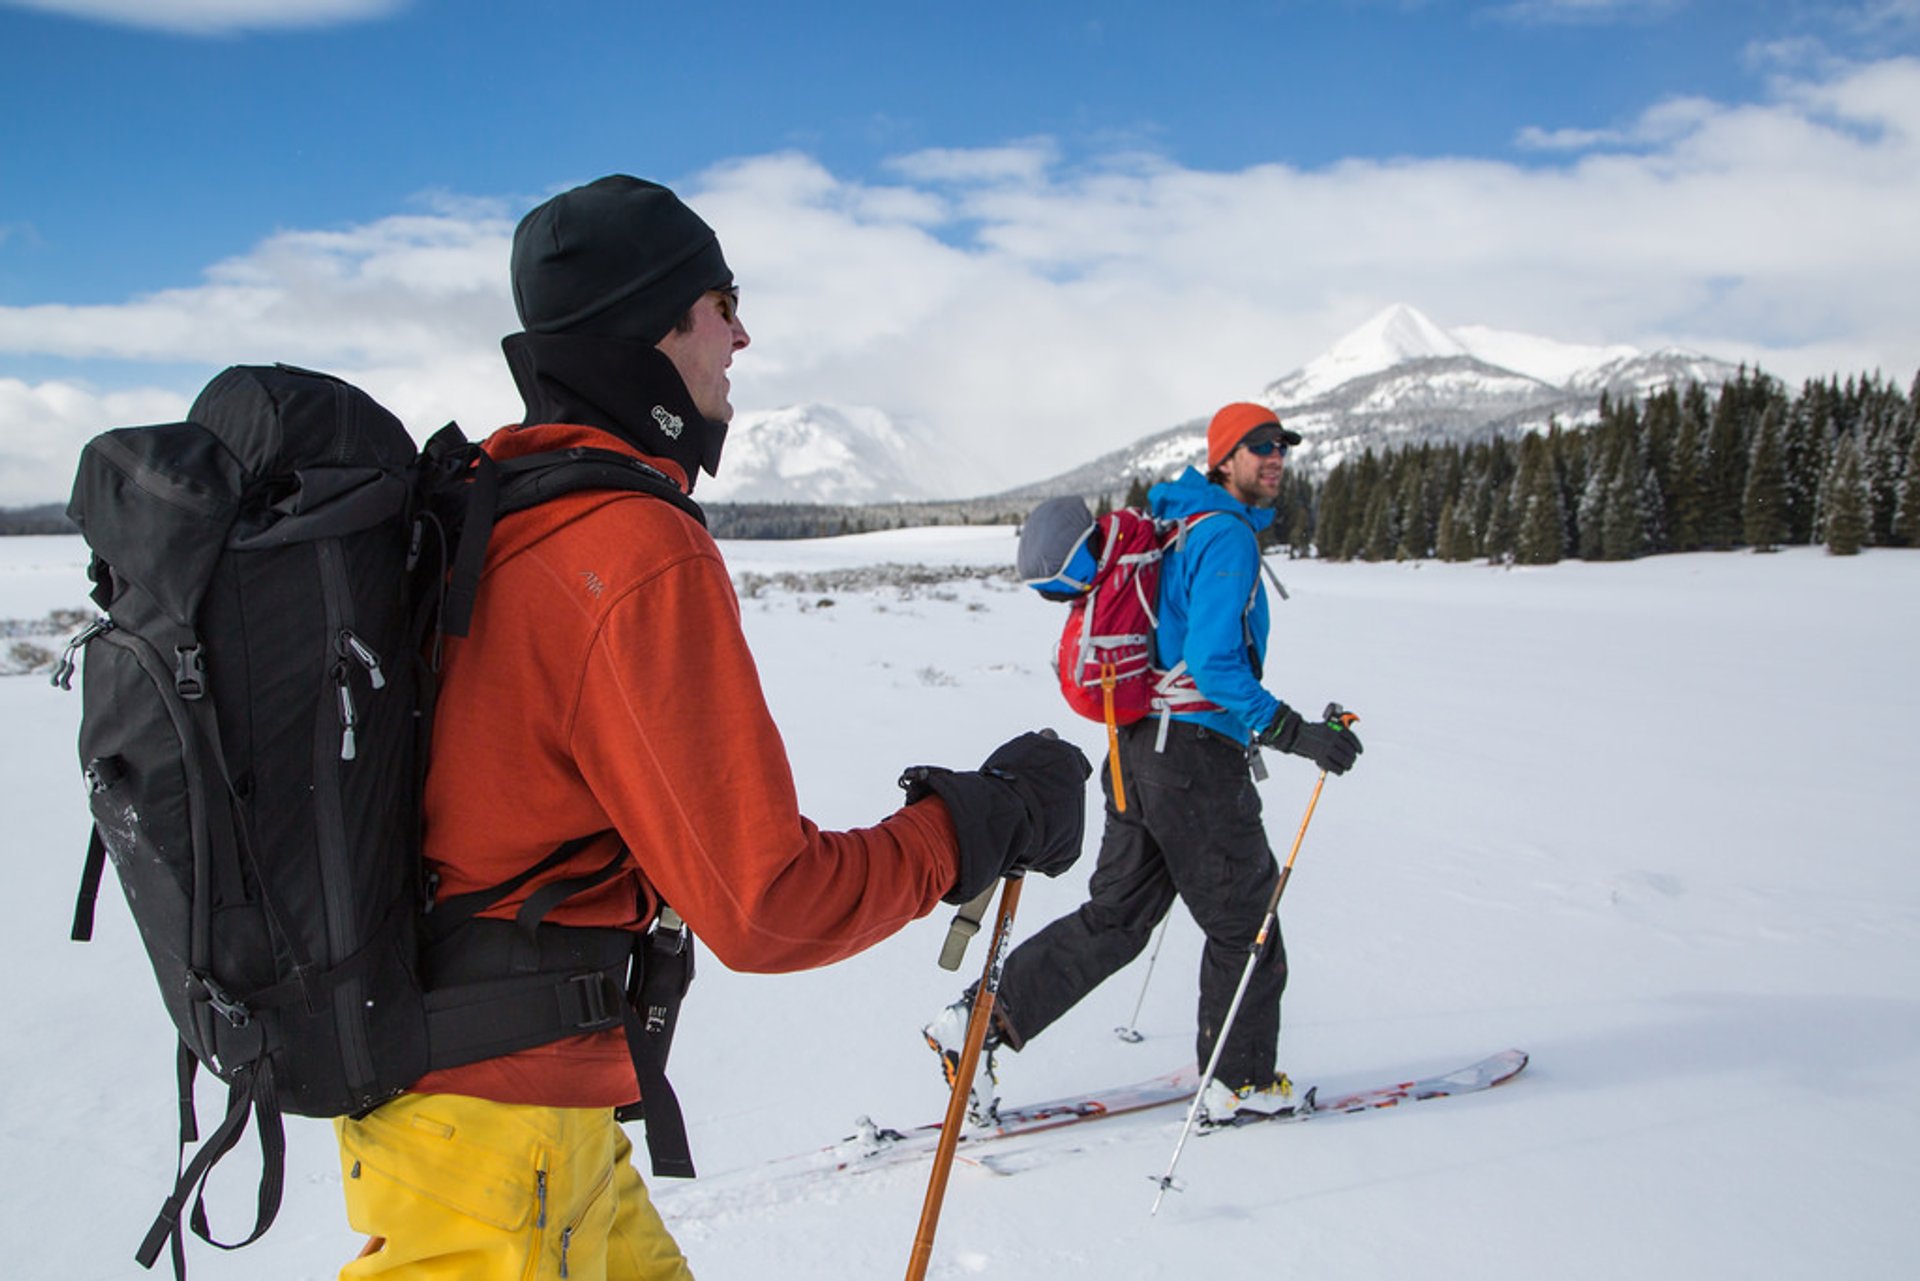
0, 528, 1920, 1281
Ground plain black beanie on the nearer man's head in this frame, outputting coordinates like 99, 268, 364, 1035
513, 173, 733, 346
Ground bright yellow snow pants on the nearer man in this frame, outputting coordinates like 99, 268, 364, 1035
334, 1095, 693, 1281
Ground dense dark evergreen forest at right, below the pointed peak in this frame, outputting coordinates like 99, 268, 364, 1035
1297, 369, 1920, 565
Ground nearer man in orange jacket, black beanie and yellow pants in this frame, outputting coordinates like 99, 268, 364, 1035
338, 175, 1089, 1281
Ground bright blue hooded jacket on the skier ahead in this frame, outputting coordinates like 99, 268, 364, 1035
1146, 467, 1281, 743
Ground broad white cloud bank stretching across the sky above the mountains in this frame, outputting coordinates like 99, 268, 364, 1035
0, 60, 1920, 501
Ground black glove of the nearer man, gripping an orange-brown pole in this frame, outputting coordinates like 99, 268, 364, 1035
900, 732, 1092, 903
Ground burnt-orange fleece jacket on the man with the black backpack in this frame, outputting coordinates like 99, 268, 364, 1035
415, 424, 958, 1106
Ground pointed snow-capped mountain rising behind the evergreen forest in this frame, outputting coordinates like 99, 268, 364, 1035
1014, 303, 1738, 497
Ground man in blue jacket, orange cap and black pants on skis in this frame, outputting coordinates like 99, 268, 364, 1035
924, 403, 1361, 1122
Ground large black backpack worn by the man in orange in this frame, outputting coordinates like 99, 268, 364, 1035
54, 365, 701, 1273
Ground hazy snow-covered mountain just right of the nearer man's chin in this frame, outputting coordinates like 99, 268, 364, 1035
697, 403, 960, 505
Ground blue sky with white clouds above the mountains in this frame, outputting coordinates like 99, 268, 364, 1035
0, 0, 1920, 503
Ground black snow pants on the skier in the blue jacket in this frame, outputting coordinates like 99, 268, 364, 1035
995, 718, 1286, 1087
